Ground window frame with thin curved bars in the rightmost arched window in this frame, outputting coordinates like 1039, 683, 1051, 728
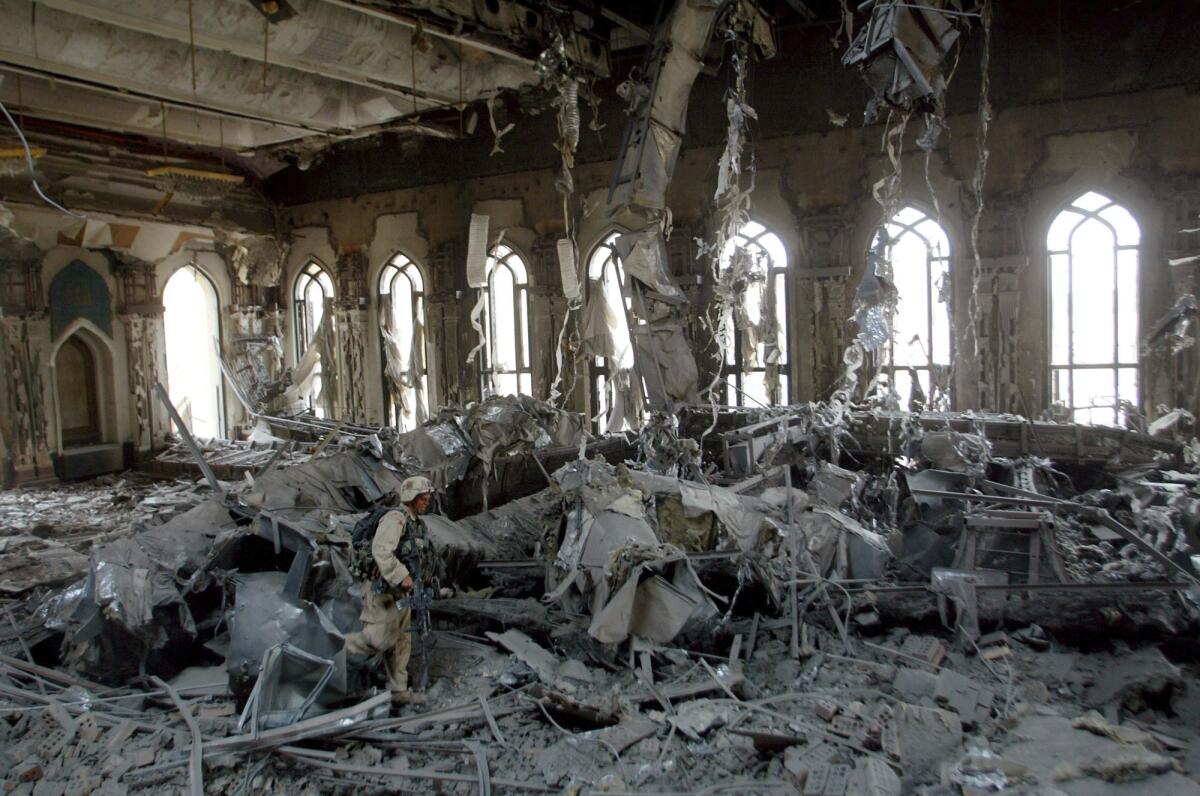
1043, 188, 1144, 426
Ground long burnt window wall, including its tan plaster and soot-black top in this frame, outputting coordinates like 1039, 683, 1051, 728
277, 2, 1200, 427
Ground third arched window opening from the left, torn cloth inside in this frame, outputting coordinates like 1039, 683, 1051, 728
379, 255, 430, 431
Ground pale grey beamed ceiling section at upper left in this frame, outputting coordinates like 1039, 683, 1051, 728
0, 0, 535, 149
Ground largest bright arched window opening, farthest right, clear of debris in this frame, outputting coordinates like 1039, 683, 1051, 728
1046, 192, 1141, 424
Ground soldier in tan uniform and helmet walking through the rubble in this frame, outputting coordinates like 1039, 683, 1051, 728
346, 475, 433, 705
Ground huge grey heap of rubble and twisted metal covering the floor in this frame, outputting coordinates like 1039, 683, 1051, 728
0, 399, 1200, 796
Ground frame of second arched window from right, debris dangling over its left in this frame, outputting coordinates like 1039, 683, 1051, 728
871, 203, 955, 407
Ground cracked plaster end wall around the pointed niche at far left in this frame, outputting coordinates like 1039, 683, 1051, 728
0, 219, 242, 484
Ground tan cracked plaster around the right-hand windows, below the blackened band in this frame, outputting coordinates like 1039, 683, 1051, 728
281, 82, 1200, 418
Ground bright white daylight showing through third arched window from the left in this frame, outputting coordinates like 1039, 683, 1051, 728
379, 255, 430, 431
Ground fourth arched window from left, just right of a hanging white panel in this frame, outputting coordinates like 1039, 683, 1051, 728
480, 245, 533, 397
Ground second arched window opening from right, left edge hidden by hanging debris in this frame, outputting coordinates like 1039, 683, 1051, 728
872, 207, 953, 408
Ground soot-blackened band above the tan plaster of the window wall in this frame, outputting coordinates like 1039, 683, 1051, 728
264, 0, 1200, 205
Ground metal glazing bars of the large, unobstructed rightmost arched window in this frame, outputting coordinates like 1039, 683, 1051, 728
1046, 191, 1142, 425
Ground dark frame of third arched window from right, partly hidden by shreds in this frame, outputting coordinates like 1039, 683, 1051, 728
720, 219, 793, 407
